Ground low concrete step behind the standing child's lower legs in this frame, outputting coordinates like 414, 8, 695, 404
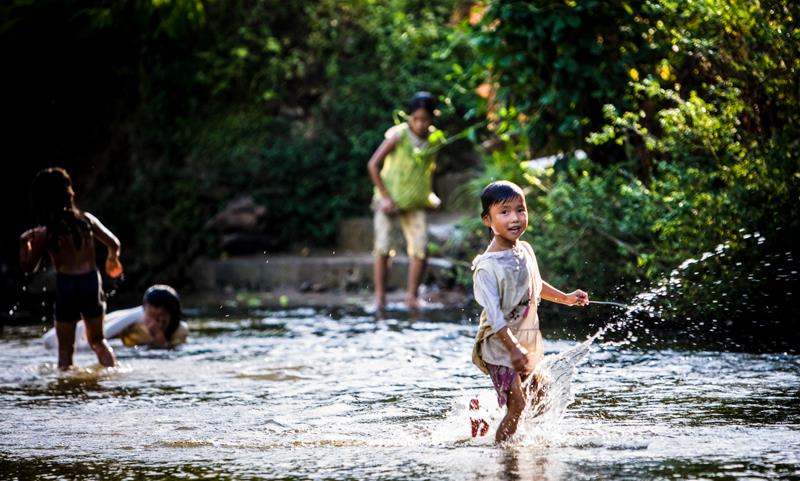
191, 253, 455, 292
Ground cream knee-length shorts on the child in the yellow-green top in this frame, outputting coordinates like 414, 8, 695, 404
374, 208, 428, 259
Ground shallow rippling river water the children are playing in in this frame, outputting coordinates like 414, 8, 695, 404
0, 307, 800, 481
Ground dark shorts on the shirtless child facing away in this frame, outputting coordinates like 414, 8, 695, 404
55, 269, 106, 322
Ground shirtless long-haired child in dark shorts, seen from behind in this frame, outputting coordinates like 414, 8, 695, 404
20, 167, 122, 370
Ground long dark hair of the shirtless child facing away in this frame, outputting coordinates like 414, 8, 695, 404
31, 167, 92, 250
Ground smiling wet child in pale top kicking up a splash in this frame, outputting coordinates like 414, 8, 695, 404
472, 181, 589, 442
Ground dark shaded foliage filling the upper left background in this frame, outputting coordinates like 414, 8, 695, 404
0, 0, 476, 283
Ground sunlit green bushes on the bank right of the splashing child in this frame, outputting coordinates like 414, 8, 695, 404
450, 0, 800, 319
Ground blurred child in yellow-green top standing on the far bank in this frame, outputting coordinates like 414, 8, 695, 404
367, 92, 440, 312
